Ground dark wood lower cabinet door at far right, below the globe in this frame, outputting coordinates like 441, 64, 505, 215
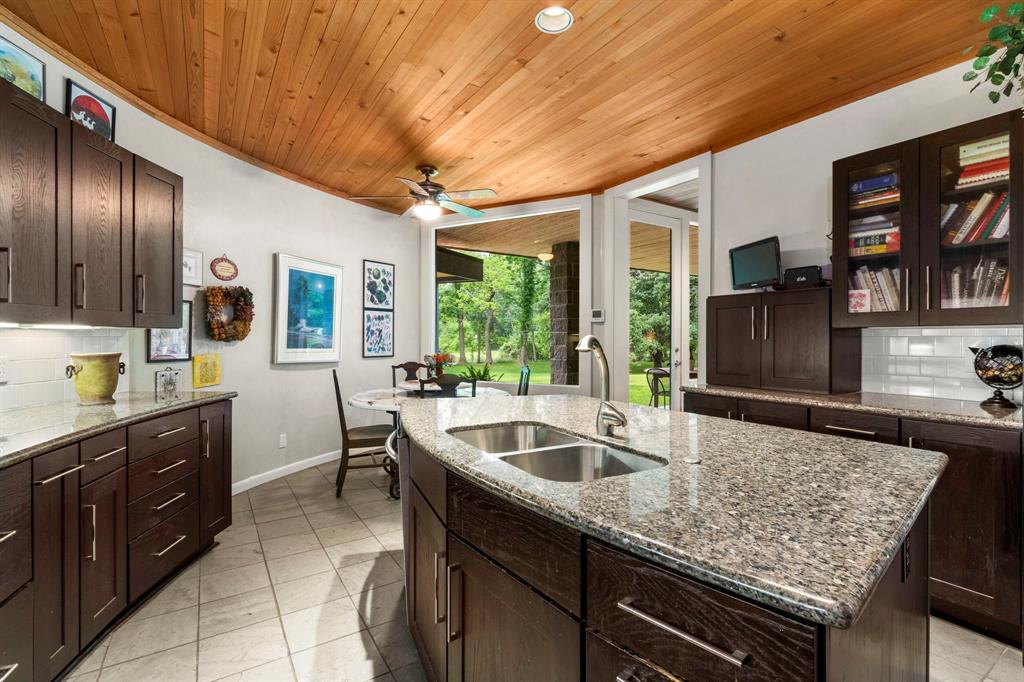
902, 419, 1022, 641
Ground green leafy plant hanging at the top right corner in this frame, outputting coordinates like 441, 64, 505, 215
964, 2, 1024, 103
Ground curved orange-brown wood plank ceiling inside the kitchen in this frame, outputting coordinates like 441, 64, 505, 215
0, 0, 989, 211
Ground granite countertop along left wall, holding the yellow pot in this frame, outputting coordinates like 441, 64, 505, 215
0, 391, 238, 469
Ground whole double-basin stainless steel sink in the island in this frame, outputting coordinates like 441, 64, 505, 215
450, 424, 665, 482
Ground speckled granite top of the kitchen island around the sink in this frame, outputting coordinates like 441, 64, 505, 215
401, 395, 946, 628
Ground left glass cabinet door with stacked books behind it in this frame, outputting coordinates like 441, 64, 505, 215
833, 140, 919, 327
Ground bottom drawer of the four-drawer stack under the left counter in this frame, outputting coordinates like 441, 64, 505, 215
128, 504, 199, 601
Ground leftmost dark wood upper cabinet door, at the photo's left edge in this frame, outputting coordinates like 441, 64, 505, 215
0, 81, 71, 323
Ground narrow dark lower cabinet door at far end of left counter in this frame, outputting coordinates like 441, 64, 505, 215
199, 400, 231, 547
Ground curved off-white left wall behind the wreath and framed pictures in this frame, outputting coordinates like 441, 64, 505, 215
0, 25, 420, 481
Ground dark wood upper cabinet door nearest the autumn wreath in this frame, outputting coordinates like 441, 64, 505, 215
133, 156, 182, 328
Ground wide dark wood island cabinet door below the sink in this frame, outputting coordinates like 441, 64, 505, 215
447, 534, 581, 682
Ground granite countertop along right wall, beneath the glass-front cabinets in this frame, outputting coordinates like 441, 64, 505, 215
681, 384, 1022, 431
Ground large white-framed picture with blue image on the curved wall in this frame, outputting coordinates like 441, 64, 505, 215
273, 253, 343, 364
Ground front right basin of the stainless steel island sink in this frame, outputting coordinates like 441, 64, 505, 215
500, 442, 665, 482
